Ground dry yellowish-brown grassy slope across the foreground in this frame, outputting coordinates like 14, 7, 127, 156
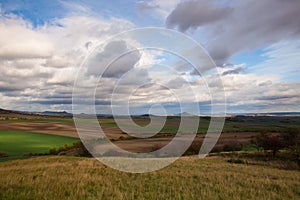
0, 157, 300, 199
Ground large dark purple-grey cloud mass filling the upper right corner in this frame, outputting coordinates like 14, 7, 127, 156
166, 0, 300, 65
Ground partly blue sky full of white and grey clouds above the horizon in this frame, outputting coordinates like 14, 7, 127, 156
0, 0, 300, 114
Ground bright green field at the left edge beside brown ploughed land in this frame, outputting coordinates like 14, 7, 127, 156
0, 131, 79, 157
